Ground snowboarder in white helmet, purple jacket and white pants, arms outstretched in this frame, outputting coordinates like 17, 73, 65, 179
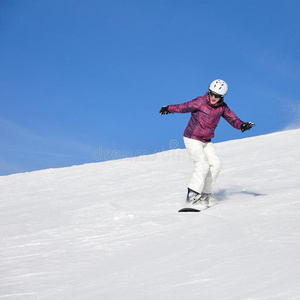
160, 79, 255, 209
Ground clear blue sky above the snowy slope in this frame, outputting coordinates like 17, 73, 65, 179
0, 0, 300, 175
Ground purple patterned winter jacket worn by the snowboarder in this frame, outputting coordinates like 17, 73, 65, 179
169, 92, 244, 143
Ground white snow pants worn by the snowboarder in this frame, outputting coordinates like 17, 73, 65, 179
183, 137, 222, 193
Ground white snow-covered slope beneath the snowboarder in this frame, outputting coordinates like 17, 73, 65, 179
0, 129, 300, 300
